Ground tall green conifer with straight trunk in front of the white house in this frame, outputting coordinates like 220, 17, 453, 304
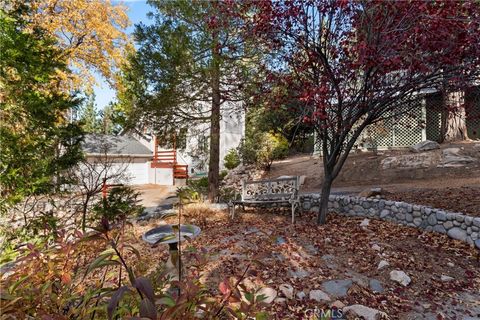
123, 0, 256, 200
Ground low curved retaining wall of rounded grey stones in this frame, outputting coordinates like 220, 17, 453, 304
300, 194, 480, 244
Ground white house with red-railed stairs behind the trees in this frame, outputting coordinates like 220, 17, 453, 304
82, 106, 245, 185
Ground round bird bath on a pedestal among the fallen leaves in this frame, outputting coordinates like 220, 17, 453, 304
142, 224, 201, 280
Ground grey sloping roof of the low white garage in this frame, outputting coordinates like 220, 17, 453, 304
82, 134, 152, 157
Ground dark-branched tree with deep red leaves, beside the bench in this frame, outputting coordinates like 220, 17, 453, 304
240, 0, 480, 224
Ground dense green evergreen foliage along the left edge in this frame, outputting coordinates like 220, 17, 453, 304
0, 11, 81, 210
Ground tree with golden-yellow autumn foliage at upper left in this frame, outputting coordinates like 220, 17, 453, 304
15, 0, 133, 89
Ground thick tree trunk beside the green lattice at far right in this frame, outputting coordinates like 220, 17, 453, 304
442, 92, 468, 142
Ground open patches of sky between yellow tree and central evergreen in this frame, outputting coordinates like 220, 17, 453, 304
93, 0, 151, 110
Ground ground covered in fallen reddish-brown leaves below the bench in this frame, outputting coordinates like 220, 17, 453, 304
132, 209, 480, 319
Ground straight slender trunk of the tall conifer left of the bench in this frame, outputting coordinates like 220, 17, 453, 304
208, 39, 221, 202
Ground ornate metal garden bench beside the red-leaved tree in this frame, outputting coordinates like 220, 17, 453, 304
228, 177, 300, 223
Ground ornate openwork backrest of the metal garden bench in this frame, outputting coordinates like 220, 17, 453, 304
242, 177, 299, 201
